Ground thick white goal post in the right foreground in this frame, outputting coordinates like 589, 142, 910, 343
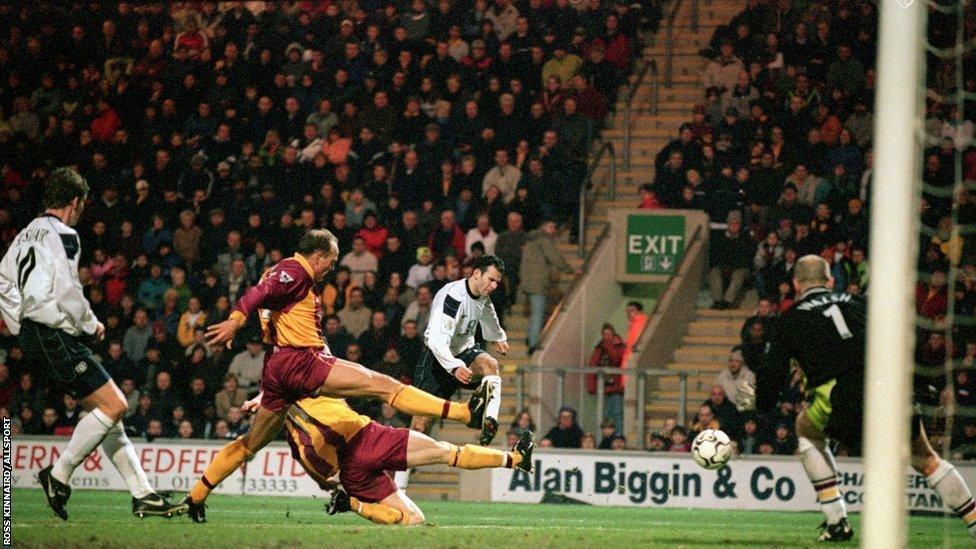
861, 0, 926, 549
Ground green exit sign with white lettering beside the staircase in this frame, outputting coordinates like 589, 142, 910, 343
626, 215, 685, 274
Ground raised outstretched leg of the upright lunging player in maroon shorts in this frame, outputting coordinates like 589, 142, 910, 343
320, 359, 482, 423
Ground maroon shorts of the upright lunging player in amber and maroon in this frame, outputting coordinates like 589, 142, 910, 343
261, 347, 336, 412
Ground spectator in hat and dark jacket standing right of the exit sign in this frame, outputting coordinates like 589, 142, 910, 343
708, 210, 754, 309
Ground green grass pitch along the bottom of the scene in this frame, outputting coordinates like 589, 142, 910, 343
13, 489, 972, 549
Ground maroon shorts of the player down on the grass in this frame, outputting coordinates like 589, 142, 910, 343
339, 421, 410, 503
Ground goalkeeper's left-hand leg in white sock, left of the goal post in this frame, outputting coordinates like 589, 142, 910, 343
796, 412, 854, 541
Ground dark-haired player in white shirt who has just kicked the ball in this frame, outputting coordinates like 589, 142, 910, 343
395, 255, 508, 488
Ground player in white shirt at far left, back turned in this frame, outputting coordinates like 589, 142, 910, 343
0, 168, 187, 520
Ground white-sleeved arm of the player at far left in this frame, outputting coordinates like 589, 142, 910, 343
50, 234, 99, 335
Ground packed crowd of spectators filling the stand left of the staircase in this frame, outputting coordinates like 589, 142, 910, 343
0, 0, 657, 440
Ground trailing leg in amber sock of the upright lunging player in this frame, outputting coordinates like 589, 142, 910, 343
182, 406, 288, 522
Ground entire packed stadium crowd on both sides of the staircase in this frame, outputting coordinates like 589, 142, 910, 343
7, 0, 976, 459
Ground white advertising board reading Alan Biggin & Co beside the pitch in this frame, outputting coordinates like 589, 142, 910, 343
460, 449, 976, 512
